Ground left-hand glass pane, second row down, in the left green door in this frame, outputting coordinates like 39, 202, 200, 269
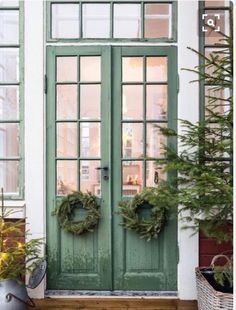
57, 85, 77, 119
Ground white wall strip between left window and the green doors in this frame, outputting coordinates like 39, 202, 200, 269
24, 0, 45, 298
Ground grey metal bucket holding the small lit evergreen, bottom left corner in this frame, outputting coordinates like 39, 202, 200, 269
0, 279, 28, 310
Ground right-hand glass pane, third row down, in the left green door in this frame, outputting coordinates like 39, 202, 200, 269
80, 122, 100, 157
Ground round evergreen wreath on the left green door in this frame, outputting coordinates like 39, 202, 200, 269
52, 191, 100, 235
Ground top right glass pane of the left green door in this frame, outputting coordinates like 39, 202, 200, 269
80, 56, 101, 82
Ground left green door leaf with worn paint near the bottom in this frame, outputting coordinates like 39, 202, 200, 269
47, 47, 112, 290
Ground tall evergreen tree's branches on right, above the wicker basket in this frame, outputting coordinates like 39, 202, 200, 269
155, 14, 233, 242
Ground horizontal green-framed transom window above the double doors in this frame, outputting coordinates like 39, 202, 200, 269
47, 0, 176, 42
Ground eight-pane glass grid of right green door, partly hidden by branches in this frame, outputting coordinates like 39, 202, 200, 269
121, 55, 168, 196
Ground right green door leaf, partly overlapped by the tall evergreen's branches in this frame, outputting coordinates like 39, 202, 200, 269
112, 47, 177, 291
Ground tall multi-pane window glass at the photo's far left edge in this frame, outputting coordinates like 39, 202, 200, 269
0, 0, 23, 199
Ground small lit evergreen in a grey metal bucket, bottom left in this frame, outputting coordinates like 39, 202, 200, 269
0, 189, 42, 310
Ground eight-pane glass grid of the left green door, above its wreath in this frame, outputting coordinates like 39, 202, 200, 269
55, 55, 101, 196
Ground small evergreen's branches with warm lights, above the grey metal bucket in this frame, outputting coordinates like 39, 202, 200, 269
0, 189, 43, 281
